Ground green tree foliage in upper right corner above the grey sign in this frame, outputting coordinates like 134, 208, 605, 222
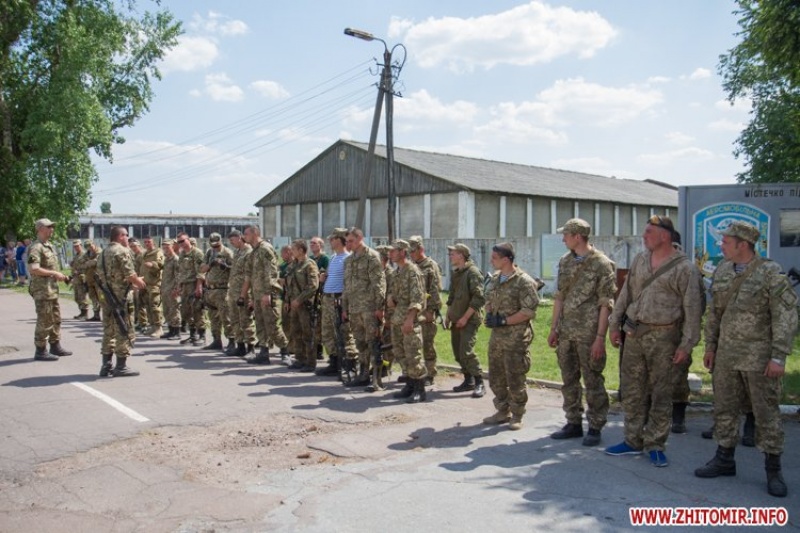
719, 0, 800, 183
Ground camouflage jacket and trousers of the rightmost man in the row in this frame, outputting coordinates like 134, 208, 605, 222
705, 259, 797, 455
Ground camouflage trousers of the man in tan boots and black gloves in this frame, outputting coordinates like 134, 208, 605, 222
489, 323, 533, 416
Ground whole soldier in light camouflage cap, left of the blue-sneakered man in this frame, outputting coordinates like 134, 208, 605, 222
547, 218, 617, 446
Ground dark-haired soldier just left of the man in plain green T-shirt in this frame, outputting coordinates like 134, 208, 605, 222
285, 239, 319, 372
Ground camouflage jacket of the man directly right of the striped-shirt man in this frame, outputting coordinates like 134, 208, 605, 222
342, 246, 386, 314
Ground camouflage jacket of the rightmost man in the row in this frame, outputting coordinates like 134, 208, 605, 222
705, 259, 797, 371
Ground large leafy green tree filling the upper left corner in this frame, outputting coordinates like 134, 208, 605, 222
0, 0, 181, 235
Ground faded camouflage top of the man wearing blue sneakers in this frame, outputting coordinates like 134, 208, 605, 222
609, 250, 703, 352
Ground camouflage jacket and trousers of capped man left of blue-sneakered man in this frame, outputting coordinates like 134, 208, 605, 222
554, 248, 617, 430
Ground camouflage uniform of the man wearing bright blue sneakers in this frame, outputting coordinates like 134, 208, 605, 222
609, 251, 702, 451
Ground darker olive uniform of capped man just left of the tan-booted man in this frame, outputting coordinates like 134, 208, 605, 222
447, 260, 486, 378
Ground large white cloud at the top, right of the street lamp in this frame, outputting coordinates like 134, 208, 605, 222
389, 1, 617, 72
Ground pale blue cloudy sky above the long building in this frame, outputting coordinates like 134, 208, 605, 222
89, 0, 750, 215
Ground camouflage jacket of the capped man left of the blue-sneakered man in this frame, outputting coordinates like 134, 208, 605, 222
553, 248, 617, 340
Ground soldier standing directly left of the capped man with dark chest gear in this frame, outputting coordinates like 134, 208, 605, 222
172, 233, 206, 346
